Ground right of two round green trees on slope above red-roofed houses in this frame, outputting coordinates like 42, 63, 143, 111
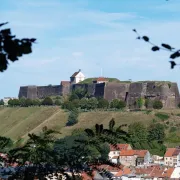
148, 123, 165, 143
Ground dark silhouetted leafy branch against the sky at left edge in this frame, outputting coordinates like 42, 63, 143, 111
0, 22, 36, 72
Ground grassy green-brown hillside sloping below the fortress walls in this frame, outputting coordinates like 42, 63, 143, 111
0, 107, 180, 146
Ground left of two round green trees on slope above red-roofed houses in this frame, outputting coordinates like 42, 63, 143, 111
128, 122, 148, 142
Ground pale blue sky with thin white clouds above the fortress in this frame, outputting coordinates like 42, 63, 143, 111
0, 0, 180, 98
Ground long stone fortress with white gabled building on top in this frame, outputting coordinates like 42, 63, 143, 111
19, 70, 180, 108
